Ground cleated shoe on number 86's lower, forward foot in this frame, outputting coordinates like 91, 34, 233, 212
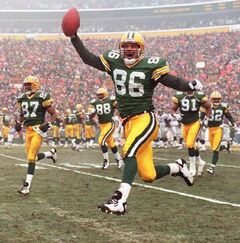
97, 191, 127, 215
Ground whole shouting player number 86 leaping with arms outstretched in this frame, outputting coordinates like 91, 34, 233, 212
68, 32, 202, 214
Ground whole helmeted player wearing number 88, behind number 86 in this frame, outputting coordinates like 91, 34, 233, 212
90, 88, 123, 170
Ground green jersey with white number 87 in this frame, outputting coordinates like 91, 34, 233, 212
17, 90, 53, 126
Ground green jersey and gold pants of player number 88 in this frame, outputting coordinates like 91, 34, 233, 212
90, 98, 117, 148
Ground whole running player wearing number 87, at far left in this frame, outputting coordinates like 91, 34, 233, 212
15, 76, 57, 195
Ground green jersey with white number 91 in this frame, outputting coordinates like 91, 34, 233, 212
172, 91, 207, 124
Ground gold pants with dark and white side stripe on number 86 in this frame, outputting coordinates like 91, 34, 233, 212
123, 113, 159, 181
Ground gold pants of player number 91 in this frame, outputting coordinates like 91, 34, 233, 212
182, 121, 201, 148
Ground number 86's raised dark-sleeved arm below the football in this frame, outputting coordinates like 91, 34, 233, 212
71, 34, 106, 71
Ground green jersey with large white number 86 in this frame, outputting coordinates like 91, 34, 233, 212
100, 50, 170, 118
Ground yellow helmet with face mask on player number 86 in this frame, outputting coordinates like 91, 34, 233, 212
119, 32, 145, 65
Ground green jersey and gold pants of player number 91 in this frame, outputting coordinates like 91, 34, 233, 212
172, 91, 208, 148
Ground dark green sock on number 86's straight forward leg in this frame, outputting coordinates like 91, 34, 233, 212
122, 157, 137, 185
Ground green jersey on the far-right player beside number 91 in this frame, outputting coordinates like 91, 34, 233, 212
208, 103, 229, 127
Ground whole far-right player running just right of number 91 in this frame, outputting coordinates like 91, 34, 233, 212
201, 91, 236, 174
